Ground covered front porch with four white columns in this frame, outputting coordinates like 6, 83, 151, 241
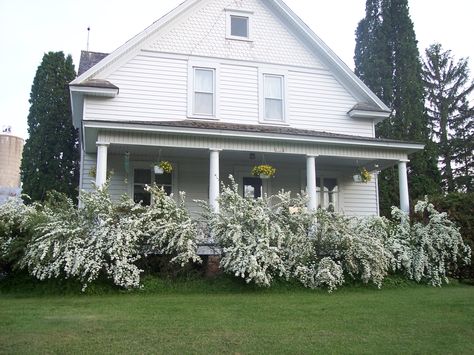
81, 121, 418, 216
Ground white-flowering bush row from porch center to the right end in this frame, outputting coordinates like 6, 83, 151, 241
205, 177, 470, 291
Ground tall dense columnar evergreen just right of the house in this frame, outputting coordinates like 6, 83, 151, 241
354, 0, 440, 215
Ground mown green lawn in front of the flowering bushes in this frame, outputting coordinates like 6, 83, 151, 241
0, 285, 474, 354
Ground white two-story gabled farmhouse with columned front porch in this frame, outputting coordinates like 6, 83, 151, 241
70, 0, 423, 215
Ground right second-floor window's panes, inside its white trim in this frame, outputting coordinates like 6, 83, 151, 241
263, 74, 285, 122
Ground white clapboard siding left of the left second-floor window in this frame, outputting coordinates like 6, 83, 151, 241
84, 54, 188, 121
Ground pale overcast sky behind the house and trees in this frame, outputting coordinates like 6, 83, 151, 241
0, 0, 474, 138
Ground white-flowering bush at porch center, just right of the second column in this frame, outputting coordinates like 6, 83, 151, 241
209, 177, 286, 286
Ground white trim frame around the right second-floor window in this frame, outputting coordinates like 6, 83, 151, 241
258, 68, 290, 126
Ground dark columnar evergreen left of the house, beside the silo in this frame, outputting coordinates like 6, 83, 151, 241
21, 52, 79, 200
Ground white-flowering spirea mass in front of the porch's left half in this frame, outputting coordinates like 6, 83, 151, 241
21, 186, 200, 289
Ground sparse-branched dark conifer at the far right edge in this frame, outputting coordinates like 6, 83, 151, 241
423, 43, 474, 192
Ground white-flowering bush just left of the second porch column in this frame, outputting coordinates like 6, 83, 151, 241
140, 185, 202, 266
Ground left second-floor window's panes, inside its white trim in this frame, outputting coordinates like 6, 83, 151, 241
193, 68, 216, 117
